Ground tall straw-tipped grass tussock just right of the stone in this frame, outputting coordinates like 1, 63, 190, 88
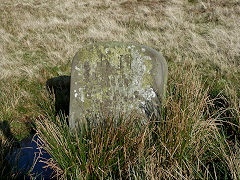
148, 65, 236, 179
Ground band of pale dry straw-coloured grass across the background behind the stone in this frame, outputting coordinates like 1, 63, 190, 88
0, 0, 240, 78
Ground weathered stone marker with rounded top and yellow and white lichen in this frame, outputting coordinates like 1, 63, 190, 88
69, 42, 167, 130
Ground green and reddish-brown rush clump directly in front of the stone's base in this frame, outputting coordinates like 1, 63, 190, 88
37, 110, 147, 179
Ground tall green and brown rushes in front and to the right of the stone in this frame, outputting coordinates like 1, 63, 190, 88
34, 63, 240, 179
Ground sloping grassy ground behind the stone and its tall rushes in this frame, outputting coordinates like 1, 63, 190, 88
0, 0, 240, 179
